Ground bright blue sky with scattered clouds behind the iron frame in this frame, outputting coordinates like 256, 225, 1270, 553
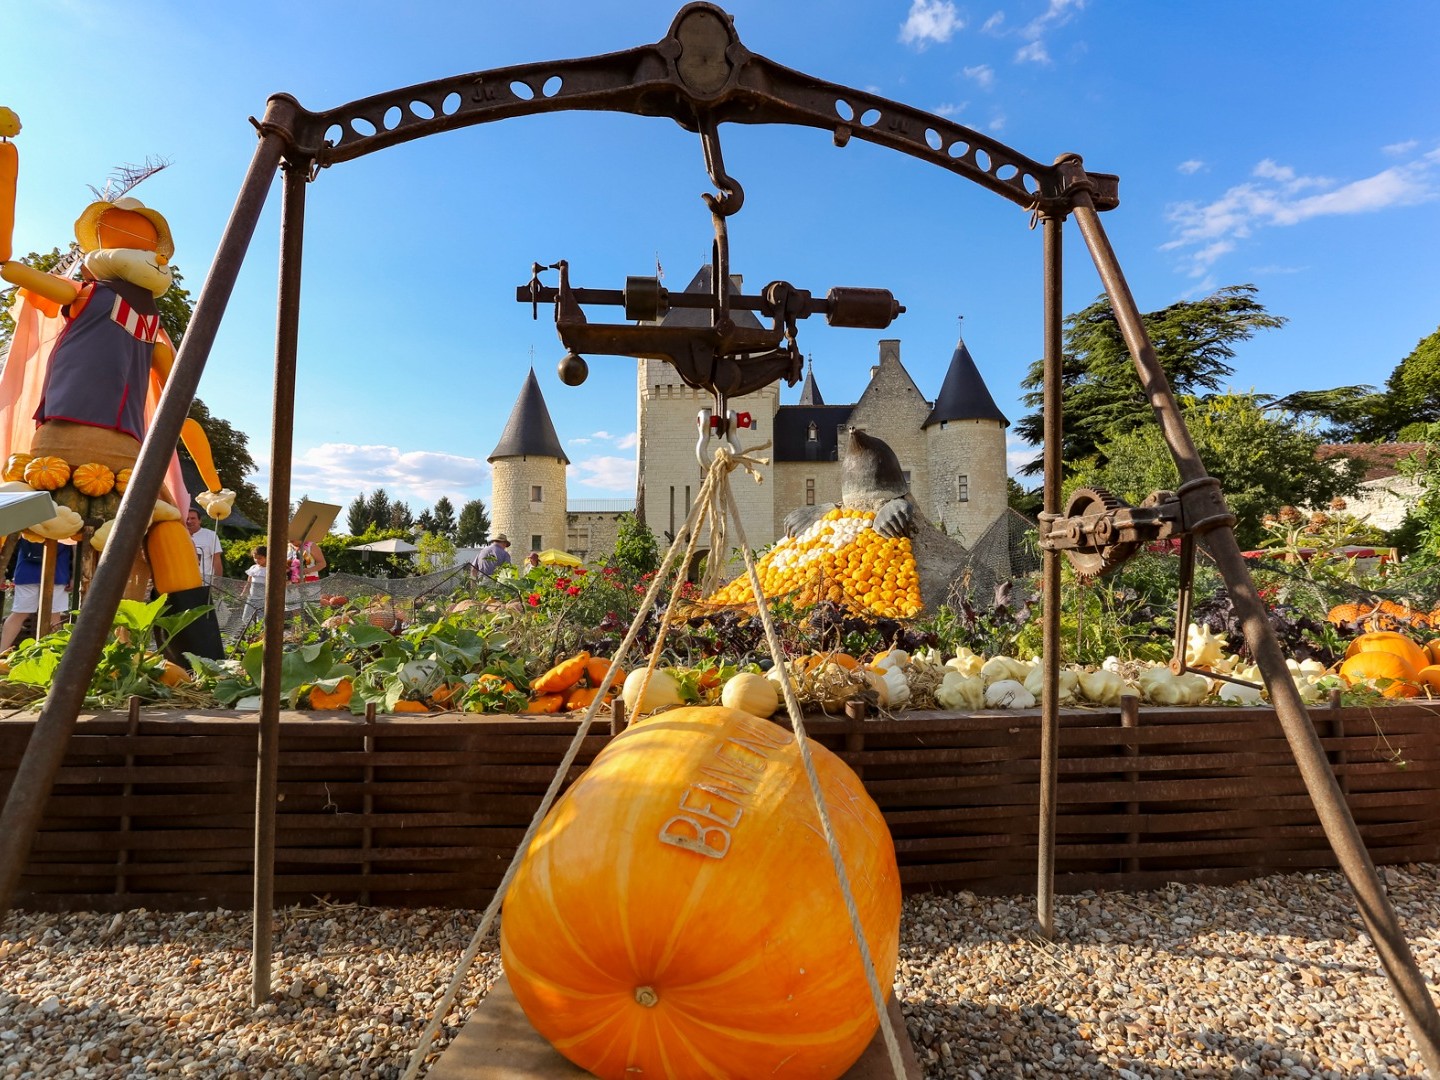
0, 0, 1440, 524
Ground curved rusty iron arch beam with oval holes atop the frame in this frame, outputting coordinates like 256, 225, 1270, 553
276, 3, 1119, 213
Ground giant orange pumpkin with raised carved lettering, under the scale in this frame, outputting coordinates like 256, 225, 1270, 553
500, 707, 900, 1080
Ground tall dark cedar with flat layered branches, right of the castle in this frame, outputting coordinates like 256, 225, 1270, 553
1015, 285, 1286, 475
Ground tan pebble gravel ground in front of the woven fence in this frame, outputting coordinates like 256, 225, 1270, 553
0, 865, 1440, 1080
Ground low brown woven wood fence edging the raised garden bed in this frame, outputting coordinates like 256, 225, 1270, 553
0, 704, 1440, 910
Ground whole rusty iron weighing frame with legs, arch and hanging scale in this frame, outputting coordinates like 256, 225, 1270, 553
0, 1, 1440, 1076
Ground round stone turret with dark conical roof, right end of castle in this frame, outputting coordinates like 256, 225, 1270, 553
922, 337, 1009, 546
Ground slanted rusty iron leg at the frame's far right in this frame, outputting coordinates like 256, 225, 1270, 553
1057, 182, 1440, 1077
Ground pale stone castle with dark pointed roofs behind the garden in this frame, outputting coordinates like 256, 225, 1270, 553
488, 265, 1009, 557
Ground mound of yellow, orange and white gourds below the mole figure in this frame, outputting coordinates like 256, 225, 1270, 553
708, 508, 920, 619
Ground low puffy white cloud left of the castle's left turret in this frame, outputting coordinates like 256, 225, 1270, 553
256, 442, 490, 511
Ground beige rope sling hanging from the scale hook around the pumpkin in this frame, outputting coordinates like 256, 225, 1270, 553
402, 442, 906, 1080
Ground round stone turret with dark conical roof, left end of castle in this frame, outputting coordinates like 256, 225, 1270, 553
487, 367, 570, 562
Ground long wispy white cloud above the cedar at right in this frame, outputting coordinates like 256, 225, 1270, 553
1161, 154, 1440, 278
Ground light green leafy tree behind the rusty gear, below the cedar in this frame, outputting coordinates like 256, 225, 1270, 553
1076, 393, 1365, 547
